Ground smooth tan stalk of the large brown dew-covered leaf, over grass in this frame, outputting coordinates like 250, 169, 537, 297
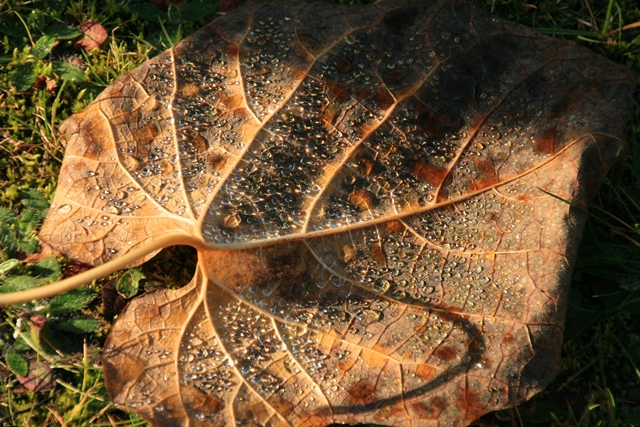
0, 235, 205, 307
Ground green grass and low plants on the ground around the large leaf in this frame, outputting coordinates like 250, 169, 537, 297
0, 0, 640, 426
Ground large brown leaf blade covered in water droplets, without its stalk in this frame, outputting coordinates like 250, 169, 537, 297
41, 0, 633, 426
